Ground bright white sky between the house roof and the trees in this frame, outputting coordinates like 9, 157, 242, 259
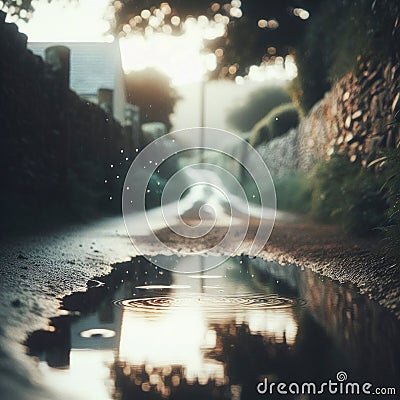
10, 0, 297, 129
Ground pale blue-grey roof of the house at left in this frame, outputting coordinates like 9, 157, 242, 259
28, 42, 123, 96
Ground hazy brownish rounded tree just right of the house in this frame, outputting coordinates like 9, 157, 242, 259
125, 68, 178, 129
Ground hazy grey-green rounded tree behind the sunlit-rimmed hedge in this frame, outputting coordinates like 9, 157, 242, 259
226, 86, 290, 132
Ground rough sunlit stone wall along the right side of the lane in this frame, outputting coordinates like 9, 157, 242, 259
258, 55, 400, 175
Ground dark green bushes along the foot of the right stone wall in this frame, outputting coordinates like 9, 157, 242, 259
274, 154, 390, 236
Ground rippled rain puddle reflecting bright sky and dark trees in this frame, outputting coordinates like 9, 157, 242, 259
27, 256, 400, 400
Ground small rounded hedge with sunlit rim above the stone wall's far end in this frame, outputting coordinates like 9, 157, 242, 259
250, 103, 299, 146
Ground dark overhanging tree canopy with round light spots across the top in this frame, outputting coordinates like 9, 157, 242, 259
3, 0, 400, 111
